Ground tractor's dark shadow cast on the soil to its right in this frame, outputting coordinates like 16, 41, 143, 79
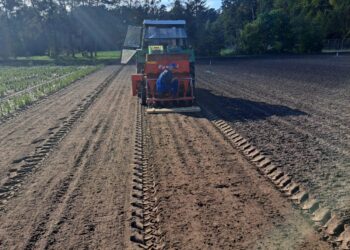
196, 88, 307, 122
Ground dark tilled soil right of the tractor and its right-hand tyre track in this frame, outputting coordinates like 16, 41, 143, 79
197, 56, 350, 215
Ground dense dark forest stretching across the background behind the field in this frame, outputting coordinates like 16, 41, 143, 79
0, 0, 350, 59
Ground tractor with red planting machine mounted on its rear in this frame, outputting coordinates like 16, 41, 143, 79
122, 20, 200, 113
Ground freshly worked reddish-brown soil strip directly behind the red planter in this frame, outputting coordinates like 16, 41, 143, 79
147, 114, 328, 249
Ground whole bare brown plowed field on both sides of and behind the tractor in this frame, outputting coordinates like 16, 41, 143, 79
0, 57, 350, 249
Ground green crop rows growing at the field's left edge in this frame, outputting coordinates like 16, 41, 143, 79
0, 66, 99, 118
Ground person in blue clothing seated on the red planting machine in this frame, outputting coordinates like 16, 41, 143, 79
156, 65, 179, 97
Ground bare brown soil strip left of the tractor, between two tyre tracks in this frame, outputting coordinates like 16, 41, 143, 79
0, 65, 135, 249
